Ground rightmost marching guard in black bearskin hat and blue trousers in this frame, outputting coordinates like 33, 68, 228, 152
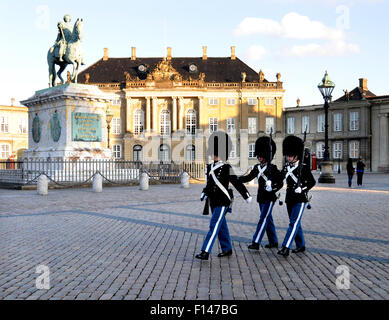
277, 135, 316, 257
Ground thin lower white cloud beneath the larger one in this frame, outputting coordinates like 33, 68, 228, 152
279, 40, 360, 57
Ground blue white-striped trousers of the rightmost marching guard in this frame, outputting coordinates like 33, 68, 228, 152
282, 202, 306, 249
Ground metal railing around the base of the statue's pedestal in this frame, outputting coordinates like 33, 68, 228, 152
0, 159, 205, 185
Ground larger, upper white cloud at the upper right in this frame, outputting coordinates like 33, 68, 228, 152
234, 12, 345, 40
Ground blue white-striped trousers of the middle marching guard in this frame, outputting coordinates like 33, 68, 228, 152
253, 201, 278, 244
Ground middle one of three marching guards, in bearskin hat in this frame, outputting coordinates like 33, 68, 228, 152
239, 136, 283, 250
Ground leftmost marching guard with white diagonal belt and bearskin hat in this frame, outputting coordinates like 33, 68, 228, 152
195, 131, 252, 260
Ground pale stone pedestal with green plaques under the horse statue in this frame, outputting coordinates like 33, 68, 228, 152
21, 83, 112, 160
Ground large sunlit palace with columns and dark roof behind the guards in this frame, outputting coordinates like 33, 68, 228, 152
78, 46, 284, 170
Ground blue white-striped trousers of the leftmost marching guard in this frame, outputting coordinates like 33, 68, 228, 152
201, 207, 232, 253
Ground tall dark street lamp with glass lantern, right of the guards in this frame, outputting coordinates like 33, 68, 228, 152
317, 71, 335, 183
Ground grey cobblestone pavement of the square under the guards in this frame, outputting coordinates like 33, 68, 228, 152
0, 174, 389, 300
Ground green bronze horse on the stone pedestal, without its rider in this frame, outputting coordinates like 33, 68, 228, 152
47, 19, 84, 87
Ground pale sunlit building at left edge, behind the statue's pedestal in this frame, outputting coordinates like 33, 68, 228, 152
0, 99, 28, 160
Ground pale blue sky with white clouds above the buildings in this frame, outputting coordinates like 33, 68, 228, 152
0, 0, 389, 107
